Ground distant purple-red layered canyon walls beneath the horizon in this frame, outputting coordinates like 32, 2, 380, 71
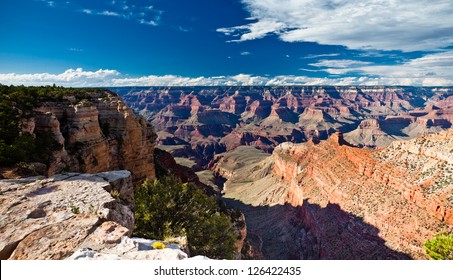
112, 86, 453, 170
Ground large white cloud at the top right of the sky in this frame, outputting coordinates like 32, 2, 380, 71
217, 0, 453, 51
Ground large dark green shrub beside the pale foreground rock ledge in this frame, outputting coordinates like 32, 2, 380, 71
134, 175, 237, 259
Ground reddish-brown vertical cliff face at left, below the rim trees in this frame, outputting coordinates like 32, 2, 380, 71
17, 91, 155, 185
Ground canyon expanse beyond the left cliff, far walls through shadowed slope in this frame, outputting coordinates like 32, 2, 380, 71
115, 86, 453, 259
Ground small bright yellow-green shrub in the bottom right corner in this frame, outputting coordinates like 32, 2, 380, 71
425, 232, 453, 260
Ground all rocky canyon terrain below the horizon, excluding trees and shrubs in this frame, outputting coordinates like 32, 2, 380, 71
0, 86, 453, 259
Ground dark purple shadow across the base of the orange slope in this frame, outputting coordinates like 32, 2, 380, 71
224, 199, 411, 260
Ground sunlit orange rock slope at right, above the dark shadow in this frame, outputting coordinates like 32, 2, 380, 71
272, 131, 453, 258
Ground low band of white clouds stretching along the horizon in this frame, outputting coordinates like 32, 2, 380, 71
0, 51, 453, 87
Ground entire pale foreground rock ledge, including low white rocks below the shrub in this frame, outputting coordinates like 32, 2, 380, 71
0, 170, 199, 260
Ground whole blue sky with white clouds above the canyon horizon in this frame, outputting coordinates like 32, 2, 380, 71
0, 0, 453, 87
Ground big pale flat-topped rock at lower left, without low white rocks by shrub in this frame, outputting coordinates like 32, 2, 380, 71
0, 171, 134, 259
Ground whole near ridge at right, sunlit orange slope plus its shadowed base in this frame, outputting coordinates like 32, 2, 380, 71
213, 130, 453, 259
